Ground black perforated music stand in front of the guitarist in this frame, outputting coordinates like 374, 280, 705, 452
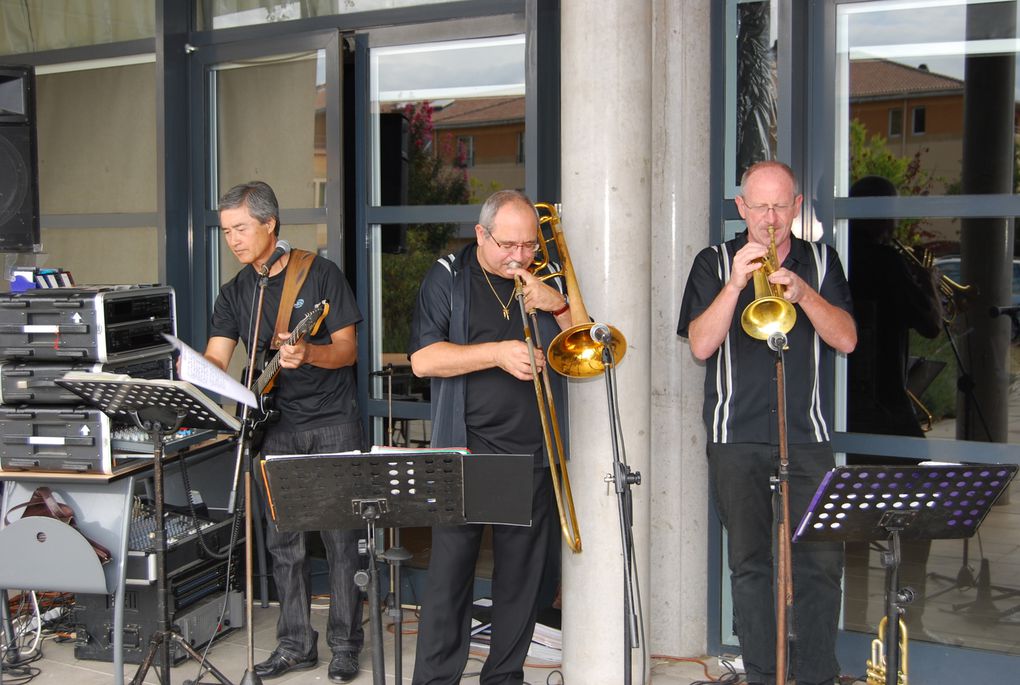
56, 371, 241, 685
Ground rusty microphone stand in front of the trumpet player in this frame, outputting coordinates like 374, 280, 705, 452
768, 332, 794, 683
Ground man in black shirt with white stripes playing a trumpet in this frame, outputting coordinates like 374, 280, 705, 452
676, 161, 857, 685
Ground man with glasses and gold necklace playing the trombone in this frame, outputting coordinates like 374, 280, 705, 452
408, 191, 570, 685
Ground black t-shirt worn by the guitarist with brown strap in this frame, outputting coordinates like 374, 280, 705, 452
209, 251, 361, 431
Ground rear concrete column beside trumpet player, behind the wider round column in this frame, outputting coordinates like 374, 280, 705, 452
645, 0, 712, 656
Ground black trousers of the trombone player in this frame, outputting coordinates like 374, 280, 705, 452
412, 468, 554, 685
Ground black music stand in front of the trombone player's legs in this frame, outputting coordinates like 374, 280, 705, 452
262, 450, 532, 685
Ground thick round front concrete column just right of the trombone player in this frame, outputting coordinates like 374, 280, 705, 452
560, 0, 652, 685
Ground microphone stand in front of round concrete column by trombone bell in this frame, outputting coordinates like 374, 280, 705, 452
593, 330, 645, 685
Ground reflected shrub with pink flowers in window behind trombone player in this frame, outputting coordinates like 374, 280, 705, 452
380, 101, 471, 353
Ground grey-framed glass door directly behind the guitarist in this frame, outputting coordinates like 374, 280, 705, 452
191, 31, 355, 377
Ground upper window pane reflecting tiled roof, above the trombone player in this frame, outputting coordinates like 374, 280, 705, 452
370, 35, 524, 206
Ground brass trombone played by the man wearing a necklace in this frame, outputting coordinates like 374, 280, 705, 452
515, 203, 626, 552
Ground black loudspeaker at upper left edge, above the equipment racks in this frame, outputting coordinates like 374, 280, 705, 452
0, 64, 40, 252
